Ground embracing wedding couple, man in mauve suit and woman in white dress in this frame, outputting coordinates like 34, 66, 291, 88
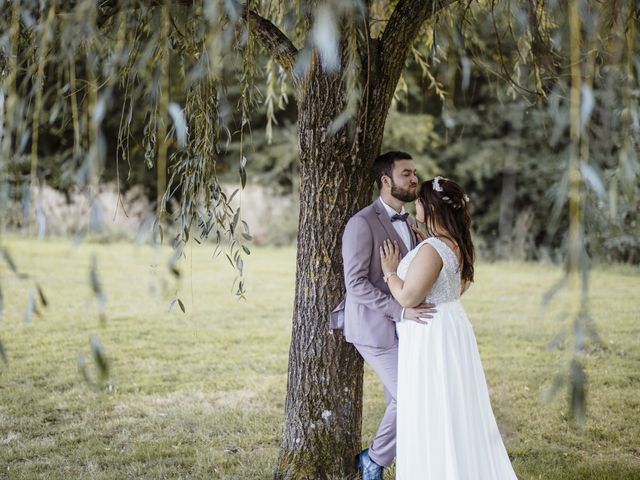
330, 152, 516, 480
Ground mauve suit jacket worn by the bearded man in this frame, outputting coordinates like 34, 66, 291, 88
329, 199, 416, 348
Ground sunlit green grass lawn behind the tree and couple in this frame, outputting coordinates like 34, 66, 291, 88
0, 237, 640, 480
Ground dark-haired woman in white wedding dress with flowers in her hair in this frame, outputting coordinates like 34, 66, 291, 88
380, 177, 516, 480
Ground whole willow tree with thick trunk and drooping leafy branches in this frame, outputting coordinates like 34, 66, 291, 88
0, 0, 638, 479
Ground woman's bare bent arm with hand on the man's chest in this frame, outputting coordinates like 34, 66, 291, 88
381, 242, 442, 308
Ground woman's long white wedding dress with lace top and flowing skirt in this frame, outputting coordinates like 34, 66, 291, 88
396, 238, 516, 480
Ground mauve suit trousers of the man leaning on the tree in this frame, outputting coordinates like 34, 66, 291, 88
354, 338, 398, 467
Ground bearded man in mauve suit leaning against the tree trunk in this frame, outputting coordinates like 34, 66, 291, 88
330, 152, 435, 480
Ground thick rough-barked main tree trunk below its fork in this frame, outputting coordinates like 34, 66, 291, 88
275, 50, 386, 479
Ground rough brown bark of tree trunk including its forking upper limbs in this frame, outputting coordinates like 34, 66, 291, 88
242, 0, 453, 479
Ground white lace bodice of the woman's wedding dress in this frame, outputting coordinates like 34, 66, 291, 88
398, 237, 460, 305
